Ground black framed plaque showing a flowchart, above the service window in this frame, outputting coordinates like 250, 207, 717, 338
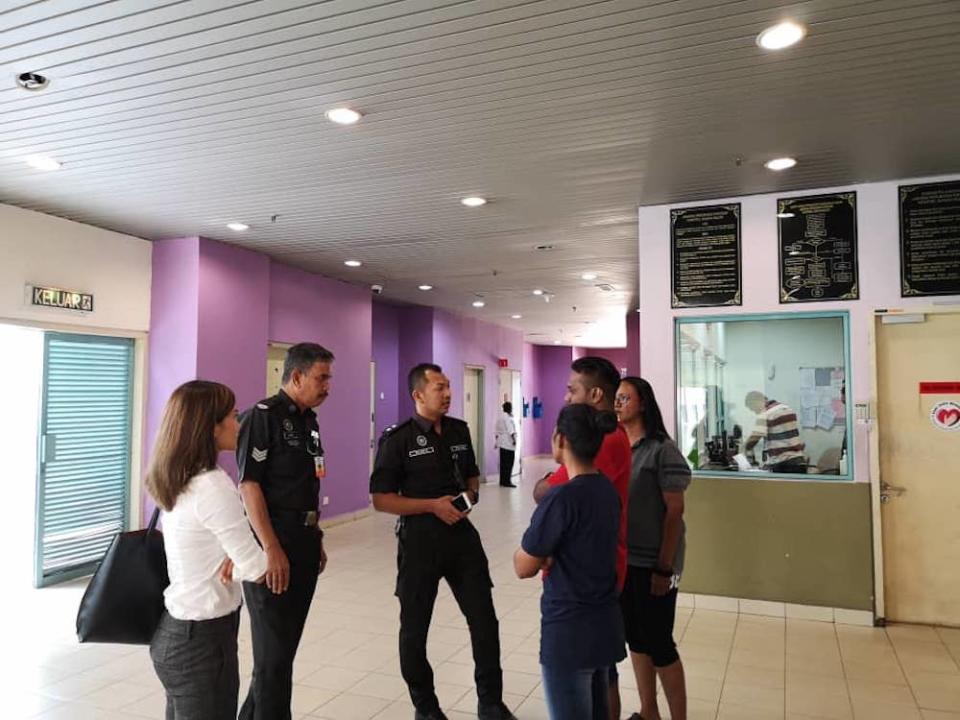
777, 192, 860, 304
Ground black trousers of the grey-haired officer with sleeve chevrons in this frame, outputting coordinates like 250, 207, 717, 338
239, 521, 320, 720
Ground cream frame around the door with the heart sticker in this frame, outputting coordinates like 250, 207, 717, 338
867, 303, 960, 625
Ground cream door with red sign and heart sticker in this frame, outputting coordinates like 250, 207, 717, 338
877, 312, 960, 625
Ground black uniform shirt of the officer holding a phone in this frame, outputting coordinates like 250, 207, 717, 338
370, 415, 480, 499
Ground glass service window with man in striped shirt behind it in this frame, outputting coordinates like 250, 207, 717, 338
676, 313, 852, 480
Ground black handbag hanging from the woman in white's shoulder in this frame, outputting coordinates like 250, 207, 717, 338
77, 508, 170, 645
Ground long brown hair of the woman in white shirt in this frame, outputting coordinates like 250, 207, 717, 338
147, 380, 237, 511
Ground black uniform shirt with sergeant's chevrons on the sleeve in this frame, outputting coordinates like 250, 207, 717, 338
237, 390, 325, 512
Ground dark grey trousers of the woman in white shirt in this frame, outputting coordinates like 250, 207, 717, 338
150, 610, 240, 720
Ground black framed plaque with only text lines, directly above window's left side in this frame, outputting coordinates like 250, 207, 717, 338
670, 203, 743, 308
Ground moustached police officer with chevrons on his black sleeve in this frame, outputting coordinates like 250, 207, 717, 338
237, 343, 333, 720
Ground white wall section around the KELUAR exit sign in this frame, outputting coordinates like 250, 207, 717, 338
0, 200, 151, 332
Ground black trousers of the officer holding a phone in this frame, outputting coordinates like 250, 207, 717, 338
396, 515, 503, 712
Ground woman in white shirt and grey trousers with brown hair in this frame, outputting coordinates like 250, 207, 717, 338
147, 380, 267, 720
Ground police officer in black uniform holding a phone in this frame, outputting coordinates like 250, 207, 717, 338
370, 363, 513, 720
